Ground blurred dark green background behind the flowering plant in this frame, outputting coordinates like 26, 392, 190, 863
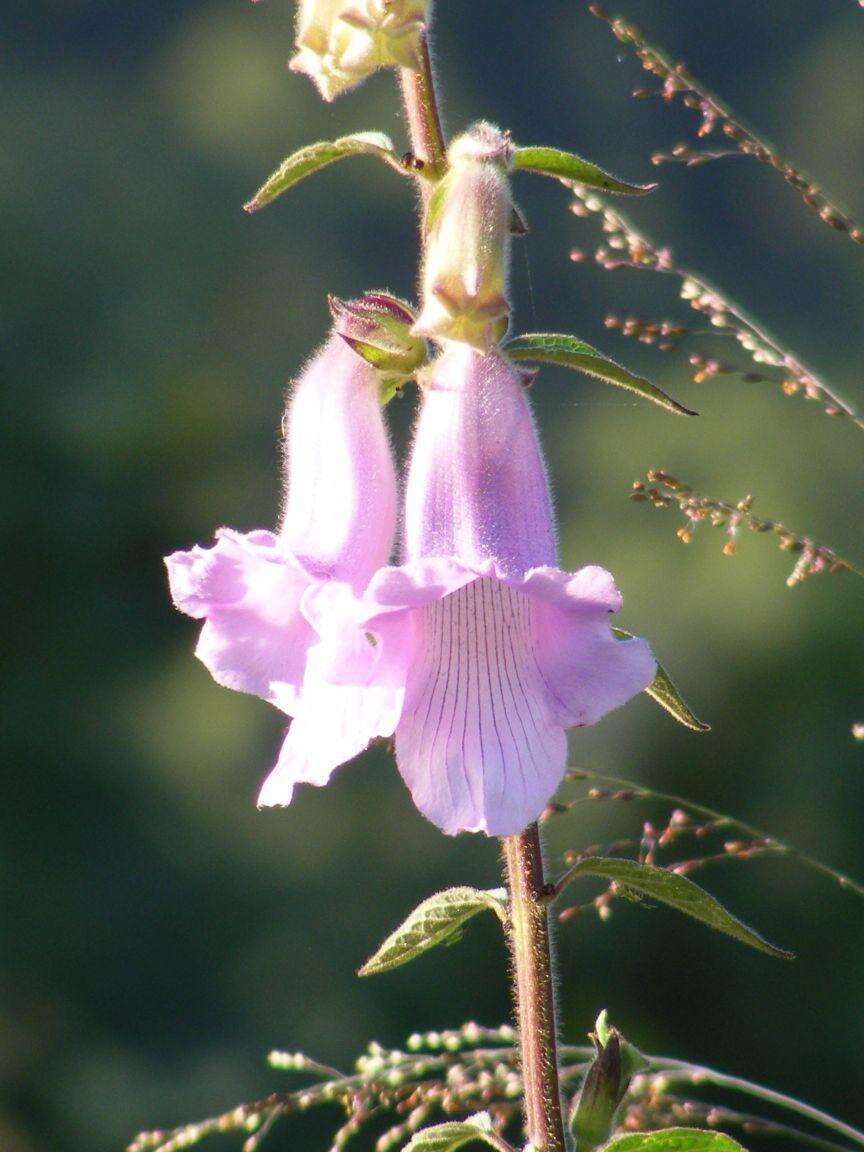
0, 0, 864, 1152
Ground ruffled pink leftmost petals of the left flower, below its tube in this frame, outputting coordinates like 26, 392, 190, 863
165, 528, 316, 715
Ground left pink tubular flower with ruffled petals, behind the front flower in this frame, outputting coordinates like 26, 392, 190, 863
166, 334, 397, 799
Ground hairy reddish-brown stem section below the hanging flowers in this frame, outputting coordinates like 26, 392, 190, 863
503, 824, 564, 1152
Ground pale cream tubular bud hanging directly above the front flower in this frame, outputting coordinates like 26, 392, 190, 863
415, 123, 514, 351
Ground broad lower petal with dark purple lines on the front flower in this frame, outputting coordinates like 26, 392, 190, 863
396, 577, 567, 836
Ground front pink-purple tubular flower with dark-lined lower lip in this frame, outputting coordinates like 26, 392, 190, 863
277, 343, 655, 836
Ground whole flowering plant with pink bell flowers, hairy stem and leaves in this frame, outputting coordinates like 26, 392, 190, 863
144, 0, 864, 1152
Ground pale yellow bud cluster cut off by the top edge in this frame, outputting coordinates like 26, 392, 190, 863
290, 0, 426, 100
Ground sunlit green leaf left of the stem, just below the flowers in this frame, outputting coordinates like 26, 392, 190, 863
358, 888, 507, 976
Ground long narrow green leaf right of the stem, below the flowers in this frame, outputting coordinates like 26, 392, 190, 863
558, 856, 794, 960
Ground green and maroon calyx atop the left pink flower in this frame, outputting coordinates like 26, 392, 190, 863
329, 291, 426, 403
